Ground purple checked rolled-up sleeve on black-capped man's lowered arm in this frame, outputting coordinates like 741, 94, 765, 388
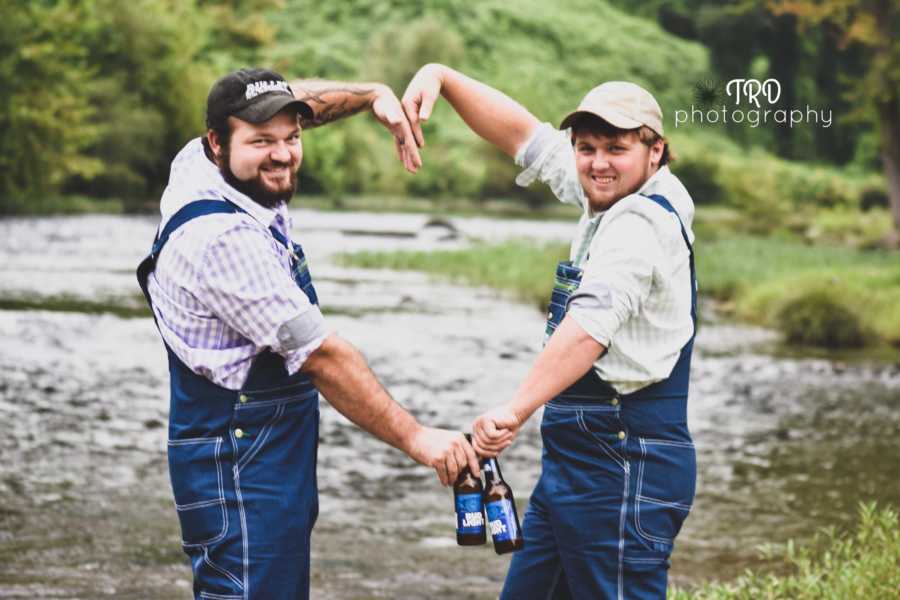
200, 223, 327, 374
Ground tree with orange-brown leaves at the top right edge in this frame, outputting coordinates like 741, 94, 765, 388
768, 0, 900, 239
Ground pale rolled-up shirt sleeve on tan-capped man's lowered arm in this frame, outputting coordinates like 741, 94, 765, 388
568, 212, 662, 348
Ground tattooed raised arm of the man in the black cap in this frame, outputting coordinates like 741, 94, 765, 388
290, 79, 422, 173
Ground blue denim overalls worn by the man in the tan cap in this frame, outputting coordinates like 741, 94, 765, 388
501, 195, 697, 600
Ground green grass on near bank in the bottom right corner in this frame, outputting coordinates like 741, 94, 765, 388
669, 504, 900, 600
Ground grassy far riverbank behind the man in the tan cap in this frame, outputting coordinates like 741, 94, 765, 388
339, 231, 900, 347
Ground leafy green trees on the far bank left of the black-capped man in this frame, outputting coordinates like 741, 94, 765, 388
0, 0, 277, 213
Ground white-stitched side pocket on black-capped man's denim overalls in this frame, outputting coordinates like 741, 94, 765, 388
168, 437, 228, 546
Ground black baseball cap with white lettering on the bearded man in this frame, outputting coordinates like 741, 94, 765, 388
206, 69, 314, 129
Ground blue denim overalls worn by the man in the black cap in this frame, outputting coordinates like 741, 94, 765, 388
138, 200, 319, 600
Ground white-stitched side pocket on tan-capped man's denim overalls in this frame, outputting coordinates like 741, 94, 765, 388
634, 438, 697, 545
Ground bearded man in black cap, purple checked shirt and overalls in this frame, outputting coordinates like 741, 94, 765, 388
138, 69, 478, 599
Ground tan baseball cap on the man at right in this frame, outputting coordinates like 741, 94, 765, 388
559, 81, 663, 135
